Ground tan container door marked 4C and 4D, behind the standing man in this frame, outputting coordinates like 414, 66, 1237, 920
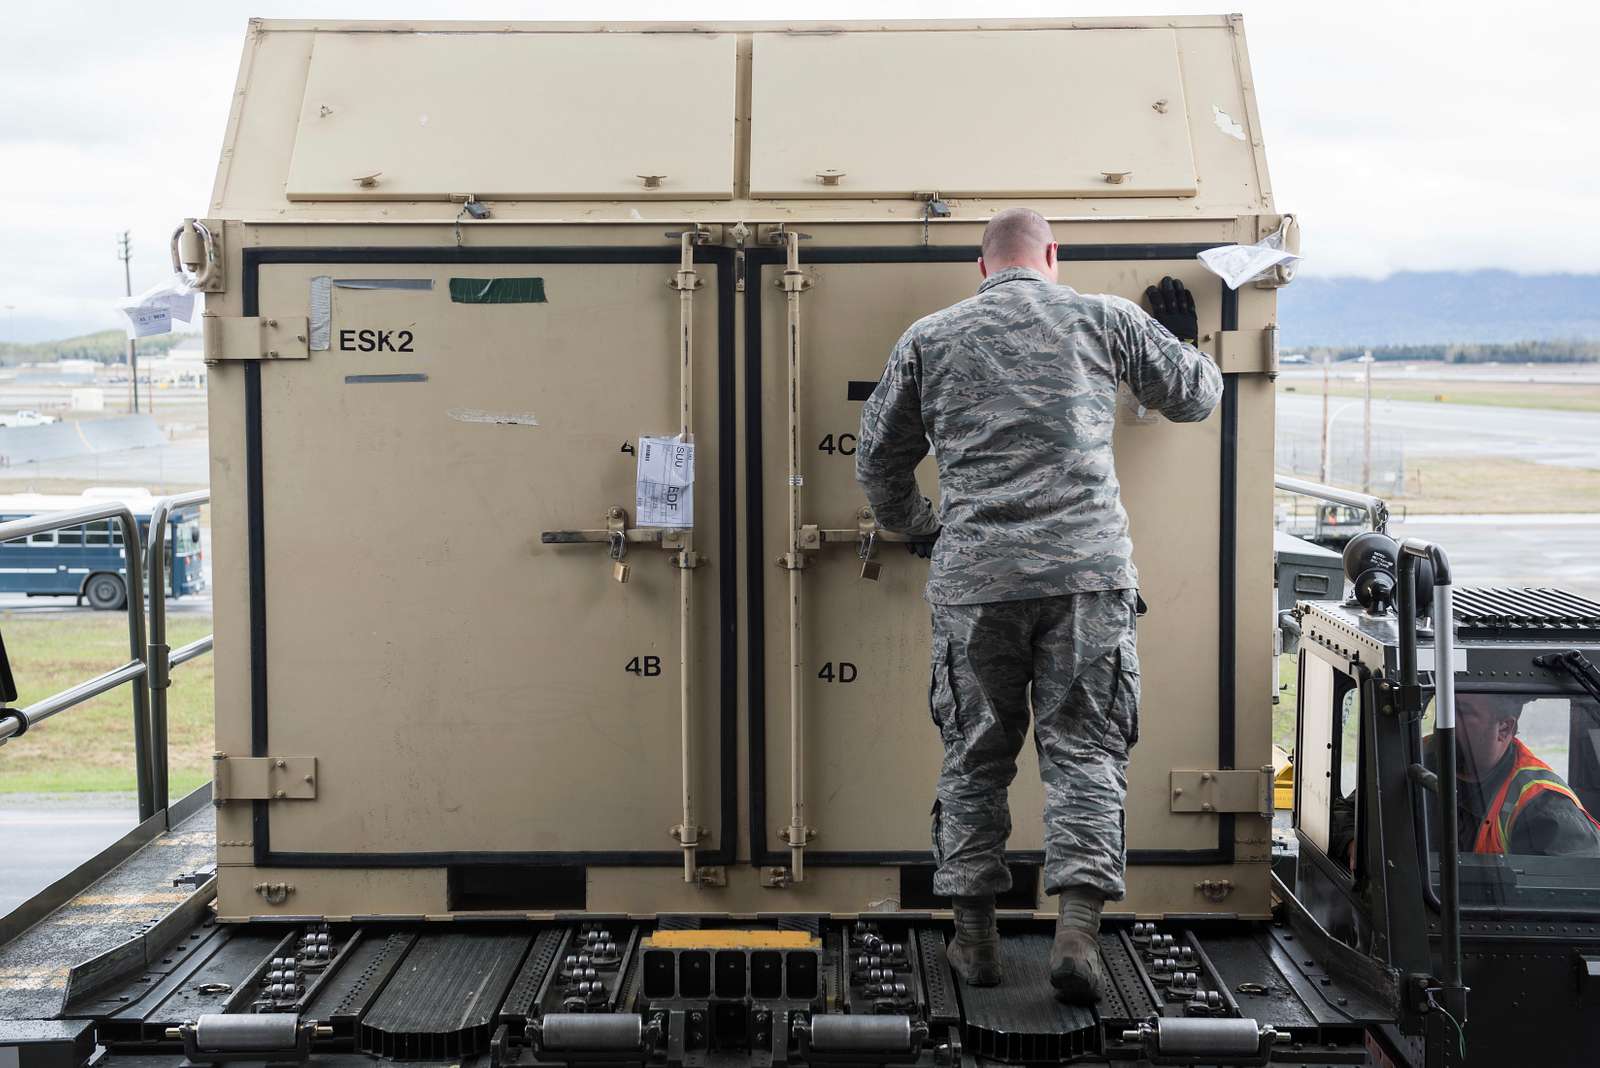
746, 246, 1232, 865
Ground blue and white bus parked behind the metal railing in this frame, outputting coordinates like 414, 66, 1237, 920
0, 489, 205, 609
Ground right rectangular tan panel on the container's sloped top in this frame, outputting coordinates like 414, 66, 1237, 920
750, 27, 1195, 198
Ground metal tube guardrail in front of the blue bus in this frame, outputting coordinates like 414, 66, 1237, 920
0, 489, 211, 822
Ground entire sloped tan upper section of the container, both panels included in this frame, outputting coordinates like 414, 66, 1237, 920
210, 16, 1272, 225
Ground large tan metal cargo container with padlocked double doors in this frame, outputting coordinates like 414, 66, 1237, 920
196, 16, 1285, 919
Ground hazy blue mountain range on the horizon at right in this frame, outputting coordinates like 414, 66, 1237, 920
1278, 270, 1600, 352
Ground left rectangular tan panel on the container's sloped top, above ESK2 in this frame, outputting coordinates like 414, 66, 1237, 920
286, 32, 734, 200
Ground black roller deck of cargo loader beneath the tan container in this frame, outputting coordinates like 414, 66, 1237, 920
0, 811, 1381, 1068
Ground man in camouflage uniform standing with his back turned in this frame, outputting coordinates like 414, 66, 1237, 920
856, 208, 1222, 1004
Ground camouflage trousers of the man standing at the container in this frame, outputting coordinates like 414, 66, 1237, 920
928, 590, 1139, 900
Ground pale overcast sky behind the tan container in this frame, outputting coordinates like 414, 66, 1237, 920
0, 0, 1600, 341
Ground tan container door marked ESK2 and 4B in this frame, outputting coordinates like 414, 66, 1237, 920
246, 254, 733, 867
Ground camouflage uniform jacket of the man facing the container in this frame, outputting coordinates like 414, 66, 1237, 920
856, 267, 1222, 604
